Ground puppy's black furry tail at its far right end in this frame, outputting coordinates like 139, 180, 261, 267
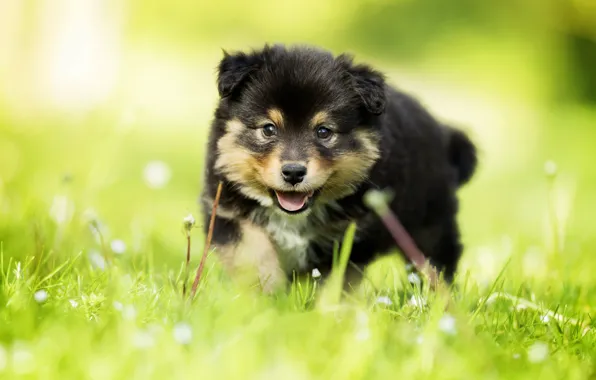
447, 127, 478, 186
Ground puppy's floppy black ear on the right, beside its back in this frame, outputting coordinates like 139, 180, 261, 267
337, 54, 386, 115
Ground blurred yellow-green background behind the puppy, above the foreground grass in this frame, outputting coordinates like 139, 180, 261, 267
0, 0, 596, 283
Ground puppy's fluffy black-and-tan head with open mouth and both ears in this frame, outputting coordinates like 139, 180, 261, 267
215, 46, 385, 213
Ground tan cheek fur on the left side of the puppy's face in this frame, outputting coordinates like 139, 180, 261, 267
214, 119, 273, 206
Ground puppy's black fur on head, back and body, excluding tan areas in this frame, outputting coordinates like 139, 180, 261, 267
203, 45, 477, 280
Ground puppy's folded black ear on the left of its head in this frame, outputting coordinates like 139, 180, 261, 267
217, 50, 262, 98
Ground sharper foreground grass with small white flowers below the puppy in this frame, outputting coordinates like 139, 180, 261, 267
0, 223, 595, 379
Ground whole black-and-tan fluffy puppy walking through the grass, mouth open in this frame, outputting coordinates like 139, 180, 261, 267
200, 45, 477, 292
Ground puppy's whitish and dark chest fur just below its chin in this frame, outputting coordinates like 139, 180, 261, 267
253, 210, 347, 273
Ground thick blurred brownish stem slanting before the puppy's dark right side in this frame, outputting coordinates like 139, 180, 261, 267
365, 190, 439, 289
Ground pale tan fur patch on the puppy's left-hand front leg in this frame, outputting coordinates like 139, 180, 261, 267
216, 221, 287, 293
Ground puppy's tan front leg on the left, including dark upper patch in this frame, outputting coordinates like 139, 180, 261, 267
213, 217, 287, 293
